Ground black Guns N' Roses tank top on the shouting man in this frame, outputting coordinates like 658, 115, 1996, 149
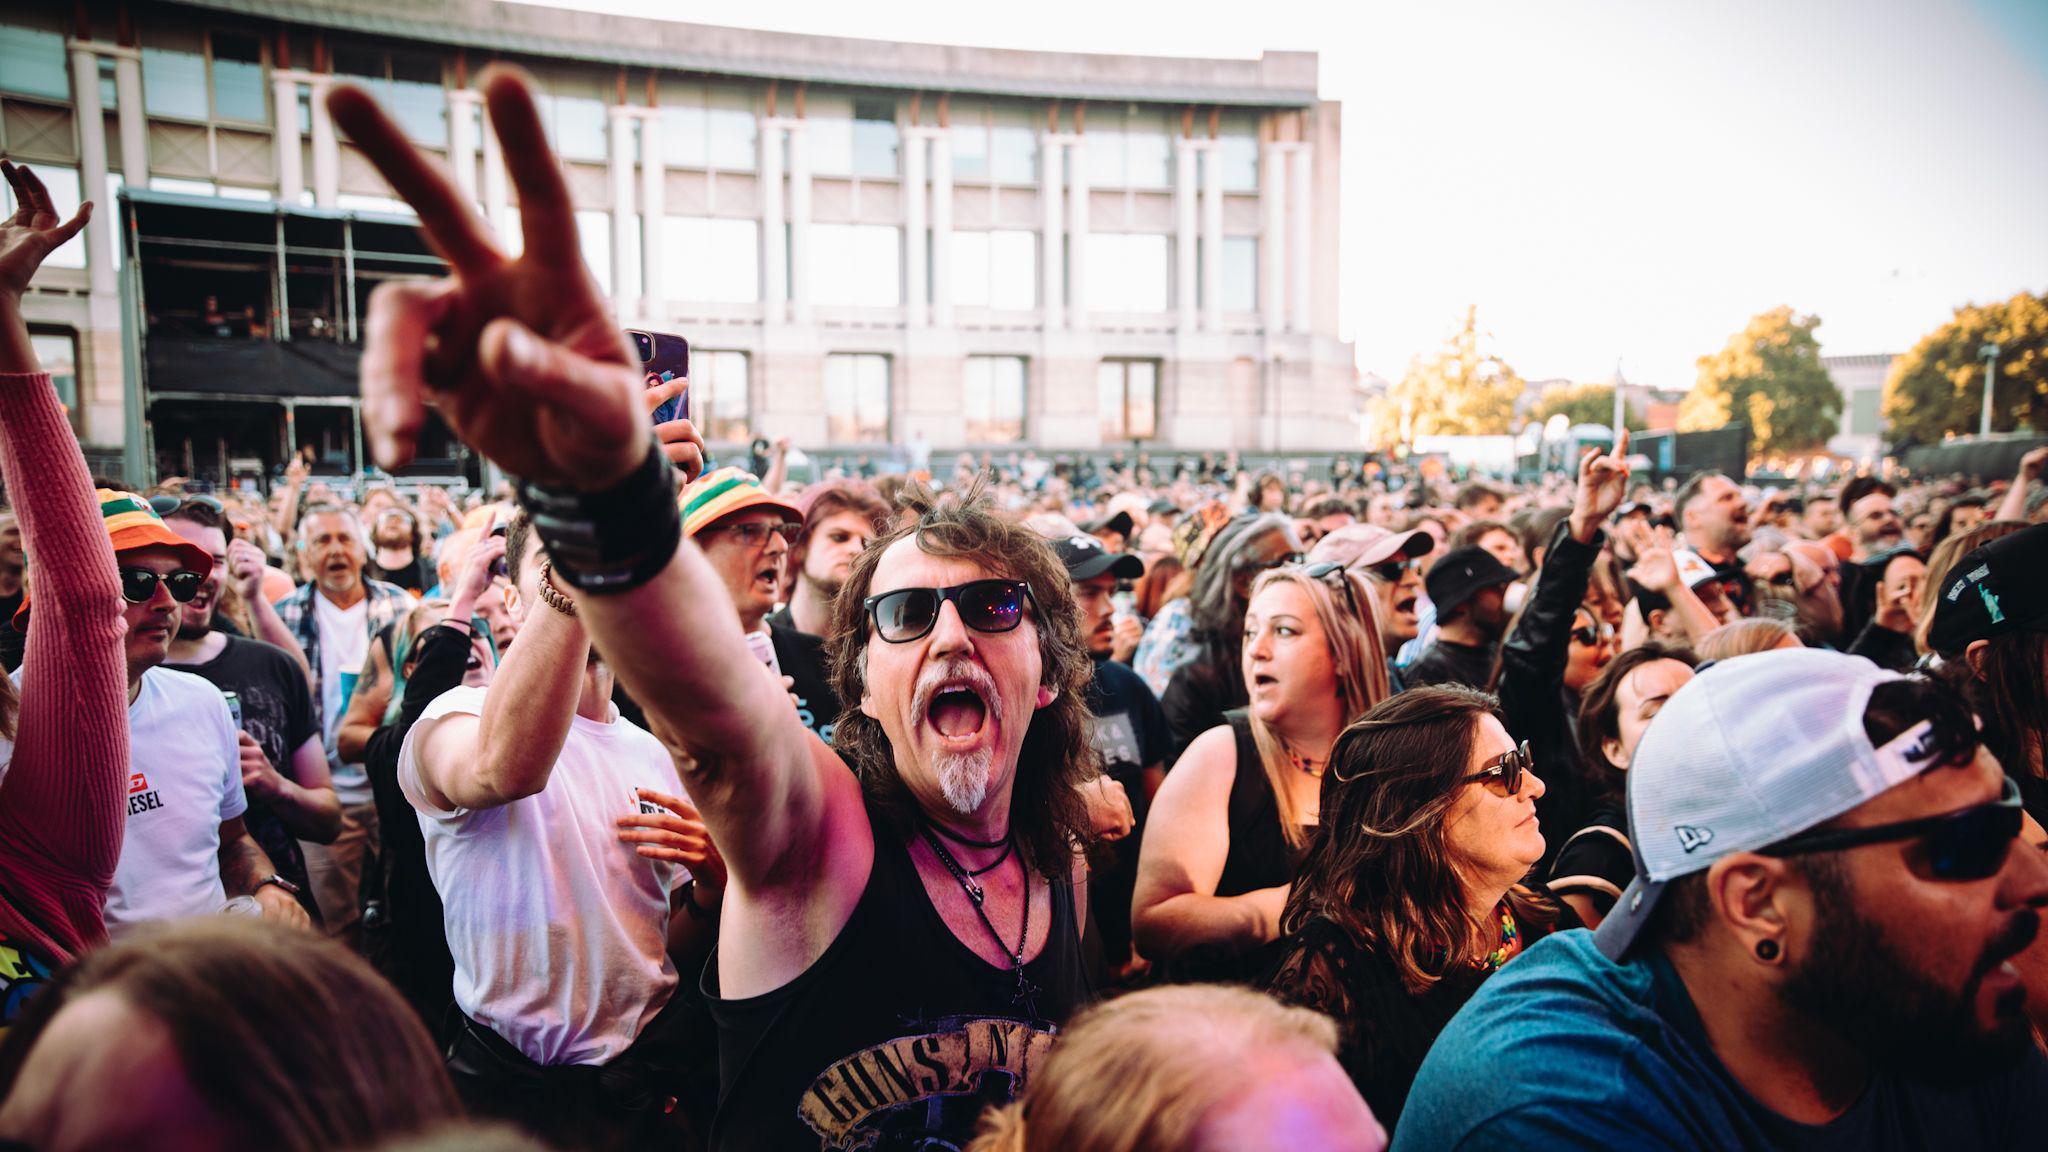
705, 812, 1094, 1152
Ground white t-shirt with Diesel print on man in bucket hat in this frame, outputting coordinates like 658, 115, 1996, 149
106, 668, 248, 939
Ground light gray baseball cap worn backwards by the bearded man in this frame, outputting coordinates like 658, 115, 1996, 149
1593, 648, 1935, 959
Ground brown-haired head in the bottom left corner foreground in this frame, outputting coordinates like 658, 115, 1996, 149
0, 916, 461, 1152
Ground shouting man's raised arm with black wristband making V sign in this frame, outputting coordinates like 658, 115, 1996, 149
328, 68, 847, 888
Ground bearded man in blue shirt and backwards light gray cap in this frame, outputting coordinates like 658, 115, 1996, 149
1395, 650, 2048, 1150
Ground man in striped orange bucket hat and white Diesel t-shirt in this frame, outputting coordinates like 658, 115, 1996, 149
14, 488, 311, 939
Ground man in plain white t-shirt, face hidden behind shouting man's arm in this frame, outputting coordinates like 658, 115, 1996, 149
397, 512, 723, 1146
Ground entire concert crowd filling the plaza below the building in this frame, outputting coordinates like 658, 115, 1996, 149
0, 70, 2048, 1152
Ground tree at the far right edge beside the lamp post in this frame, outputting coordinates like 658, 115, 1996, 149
1884, 293, 2048, 443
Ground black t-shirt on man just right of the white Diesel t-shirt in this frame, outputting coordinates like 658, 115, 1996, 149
178, 635, 319, 918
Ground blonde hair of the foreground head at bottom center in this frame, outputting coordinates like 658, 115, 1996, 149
967, 984, 1337, 1152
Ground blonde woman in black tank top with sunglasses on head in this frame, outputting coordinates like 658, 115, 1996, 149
1130, 566, 1386, 980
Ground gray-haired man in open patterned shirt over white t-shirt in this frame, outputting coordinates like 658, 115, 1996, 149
276, 504, 412, 941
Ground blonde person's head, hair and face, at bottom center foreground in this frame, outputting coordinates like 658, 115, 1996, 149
967, 984, 1386, 1152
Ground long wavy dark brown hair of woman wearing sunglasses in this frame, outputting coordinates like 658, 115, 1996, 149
1280, 687, 1559, 994
